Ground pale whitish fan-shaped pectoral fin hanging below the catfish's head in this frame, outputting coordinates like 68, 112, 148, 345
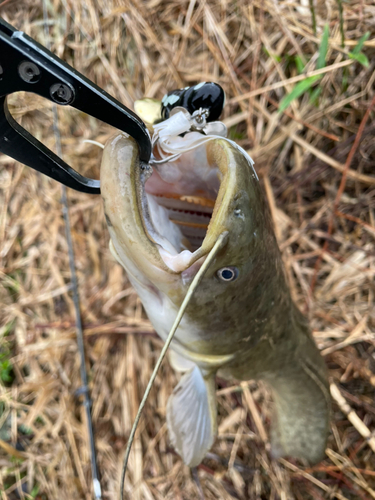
167, 366, 217, 467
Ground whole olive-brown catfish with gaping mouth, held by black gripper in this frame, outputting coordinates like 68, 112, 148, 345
101, 111, 330, 467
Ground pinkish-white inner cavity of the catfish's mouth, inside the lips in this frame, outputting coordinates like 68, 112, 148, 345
142, 139, 222, 270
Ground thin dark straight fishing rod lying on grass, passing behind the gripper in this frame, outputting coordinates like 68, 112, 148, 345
43, 4, 102, 500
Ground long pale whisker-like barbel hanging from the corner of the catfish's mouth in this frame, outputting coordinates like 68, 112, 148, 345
119, 231, 228, 500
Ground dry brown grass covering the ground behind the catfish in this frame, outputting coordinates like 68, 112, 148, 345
0, 0, 375, 500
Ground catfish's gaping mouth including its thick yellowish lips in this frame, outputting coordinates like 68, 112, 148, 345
100, 127, 255, 276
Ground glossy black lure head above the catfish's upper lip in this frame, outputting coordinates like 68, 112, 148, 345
161, 82, 225, 122
